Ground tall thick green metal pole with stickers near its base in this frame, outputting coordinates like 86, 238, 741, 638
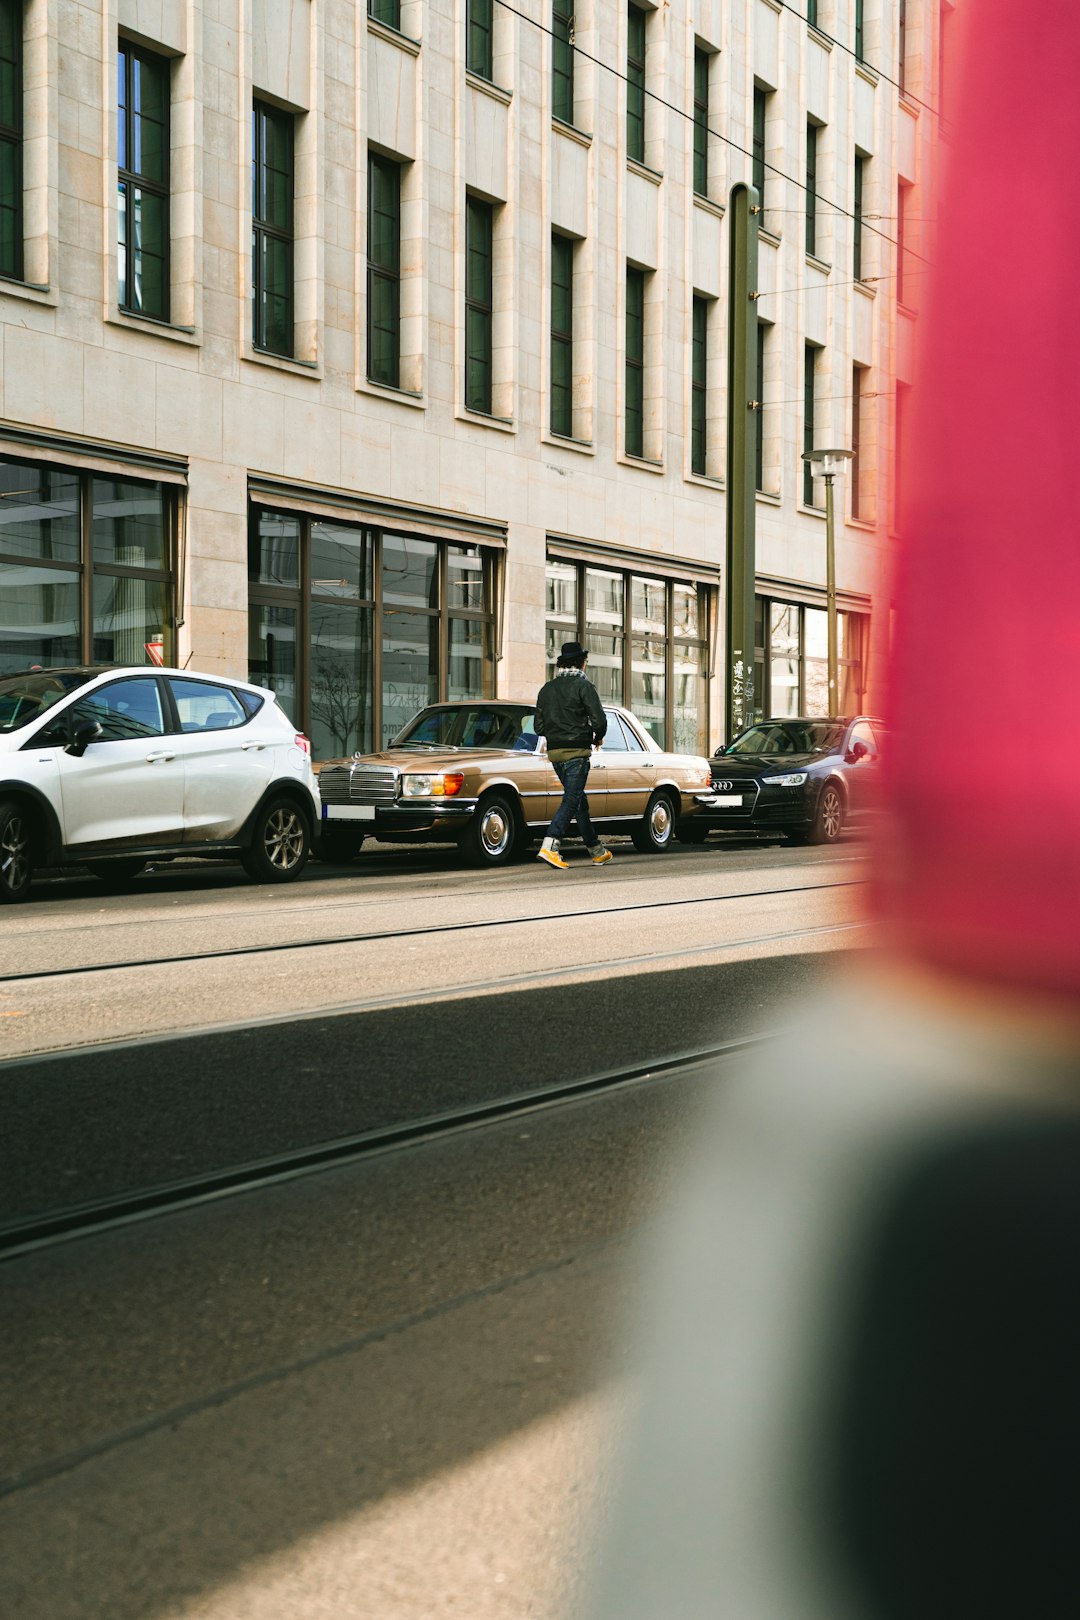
724, 181, 761, 742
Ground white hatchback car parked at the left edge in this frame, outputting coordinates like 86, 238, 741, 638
0, 666, 319, 901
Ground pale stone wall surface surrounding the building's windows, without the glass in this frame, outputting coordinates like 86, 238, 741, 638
0, 0, 939, 732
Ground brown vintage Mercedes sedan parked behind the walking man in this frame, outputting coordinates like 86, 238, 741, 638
316, 700, 711, 867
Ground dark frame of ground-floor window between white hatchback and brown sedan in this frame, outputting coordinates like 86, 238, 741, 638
248, 501, 499, 748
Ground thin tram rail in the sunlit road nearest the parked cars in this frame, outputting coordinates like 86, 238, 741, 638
3, 878, 866, 988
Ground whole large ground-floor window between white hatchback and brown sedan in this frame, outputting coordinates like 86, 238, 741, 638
248, 505, 494, 760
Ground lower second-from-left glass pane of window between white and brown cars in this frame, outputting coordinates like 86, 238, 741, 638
309, 602, 372, 760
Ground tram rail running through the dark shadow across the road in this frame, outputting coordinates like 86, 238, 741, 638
0, 1032, 764, 1264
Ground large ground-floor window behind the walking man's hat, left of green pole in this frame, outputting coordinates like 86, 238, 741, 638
546, 559, 711, 753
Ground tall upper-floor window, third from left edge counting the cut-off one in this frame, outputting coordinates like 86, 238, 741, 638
251, 102, 295, 356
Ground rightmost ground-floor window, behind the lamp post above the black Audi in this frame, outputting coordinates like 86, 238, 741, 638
755, 596, 870, 719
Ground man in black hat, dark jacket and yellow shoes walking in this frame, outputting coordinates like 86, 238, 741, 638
536, 642, 612, 872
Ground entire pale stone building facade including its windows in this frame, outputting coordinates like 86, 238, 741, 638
0, 0, 942, 757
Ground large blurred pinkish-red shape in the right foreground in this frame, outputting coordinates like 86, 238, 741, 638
887, 0, 1080, 998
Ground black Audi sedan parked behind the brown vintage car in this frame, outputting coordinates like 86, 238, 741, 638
678, 714, 881, 844
